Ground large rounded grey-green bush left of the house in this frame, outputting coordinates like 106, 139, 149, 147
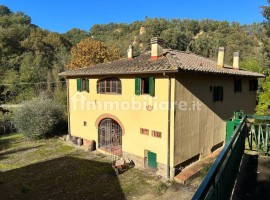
14, 96, 67, 139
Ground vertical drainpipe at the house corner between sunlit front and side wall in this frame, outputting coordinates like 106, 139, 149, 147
163, 72, 172, 179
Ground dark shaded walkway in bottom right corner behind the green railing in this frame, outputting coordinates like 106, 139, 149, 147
232, 153, 270, 200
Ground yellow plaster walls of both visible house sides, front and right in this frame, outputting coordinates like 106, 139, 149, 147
68, 73, 256, 178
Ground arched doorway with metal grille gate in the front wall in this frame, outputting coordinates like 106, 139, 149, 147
98, 118, 122, 156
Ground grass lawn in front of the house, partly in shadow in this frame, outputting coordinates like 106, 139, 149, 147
0, 134, 194, 200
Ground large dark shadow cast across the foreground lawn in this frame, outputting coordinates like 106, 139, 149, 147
0, 156, 125, 200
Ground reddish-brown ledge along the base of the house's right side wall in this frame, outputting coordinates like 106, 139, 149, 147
174, 147, 222, 184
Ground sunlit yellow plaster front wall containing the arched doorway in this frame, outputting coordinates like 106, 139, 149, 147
68, 76, 175, 175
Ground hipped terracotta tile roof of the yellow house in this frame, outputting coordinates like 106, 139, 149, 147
59, 50, 264, 78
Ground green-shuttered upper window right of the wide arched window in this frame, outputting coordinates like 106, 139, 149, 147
135, 77, 155, 96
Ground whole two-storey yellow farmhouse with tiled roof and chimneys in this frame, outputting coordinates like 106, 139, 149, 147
59, 38, 263, 178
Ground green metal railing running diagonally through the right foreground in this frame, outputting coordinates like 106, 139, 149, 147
192, 116, 247, 200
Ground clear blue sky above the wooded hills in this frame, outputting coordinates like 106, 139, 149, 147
0, 0, 267, 33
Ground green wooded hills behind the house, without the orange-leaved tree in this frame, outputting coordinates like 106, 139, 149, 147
0, 5, 270, 114
